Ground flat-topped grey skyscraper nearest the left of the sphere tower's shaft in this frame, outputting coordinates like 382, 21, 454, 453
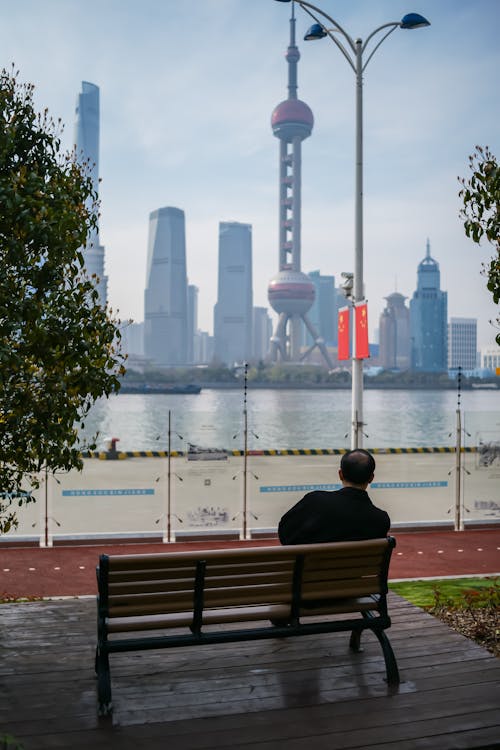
214, 221, 253, 365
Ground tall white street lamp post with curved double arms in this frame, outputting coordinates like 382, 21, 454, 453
278, 0, 430, 448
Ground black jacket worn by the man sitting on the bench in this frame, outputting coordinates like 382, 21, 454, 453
278, 487, 391, 544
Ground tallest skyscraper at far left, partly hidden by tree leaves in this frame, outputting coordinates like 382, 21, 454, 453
75, 81, 108, 305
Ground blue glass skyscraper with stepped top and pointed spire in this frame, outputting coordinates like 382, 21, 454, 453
410, 240, 448, 372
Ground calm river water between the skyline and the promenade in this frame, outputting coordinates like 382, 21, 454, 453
82, 389, 500, 451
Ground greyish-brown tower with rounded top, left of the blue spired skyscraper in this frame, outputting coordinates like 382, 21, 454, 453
379, 292, 410, 370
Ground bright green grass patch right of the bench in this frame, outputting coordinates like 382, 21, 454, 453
389, 577, 500, 609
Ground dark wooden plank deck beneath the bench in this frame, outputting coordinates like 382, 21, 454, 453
0, 594, 500, 750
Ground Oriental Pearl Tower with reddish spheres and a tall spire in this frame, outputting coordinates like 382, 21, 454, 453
268, 5, 332, 368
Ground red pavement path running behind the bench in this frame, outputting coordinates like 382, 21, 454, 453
0, 528, 500, 599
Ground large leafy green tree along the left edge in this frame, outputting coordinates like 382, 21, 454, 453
0, 70, 124, 533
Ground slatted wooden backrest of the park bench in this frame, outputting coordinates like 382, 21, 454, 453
97, 537, 395, 618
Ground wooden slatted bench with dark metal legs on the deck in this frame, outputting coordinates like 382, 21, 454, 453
95, 537, 399, 715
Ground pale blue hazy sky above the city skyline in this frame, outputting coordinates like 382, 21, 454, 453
0, 0, 500, 346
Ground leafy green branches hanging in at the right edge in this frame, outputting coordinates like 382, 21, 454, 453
458, 146, 500, 345
